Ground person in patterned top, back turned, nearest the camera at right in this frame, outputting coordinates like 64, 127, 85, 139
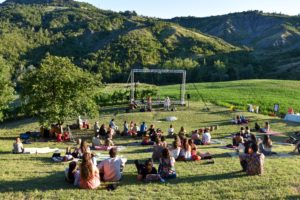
239, 142, 265, 175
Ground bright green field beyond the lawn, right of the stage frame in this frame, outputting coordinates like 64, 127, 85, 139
159, 80, 300, 114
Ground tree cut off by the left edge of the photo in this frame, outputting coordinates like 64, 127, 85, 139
0, 56, 14, 121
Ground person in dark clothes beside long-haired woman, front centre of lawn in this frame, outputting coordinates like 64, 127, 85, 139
134, 159, 165, 182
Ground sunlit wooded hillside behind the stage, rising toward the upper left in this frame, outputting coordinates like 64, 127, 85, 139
0, 0, 248, 82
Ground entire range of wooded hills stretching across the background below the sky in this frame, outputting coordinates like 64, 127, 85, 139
0, 0, 300, 84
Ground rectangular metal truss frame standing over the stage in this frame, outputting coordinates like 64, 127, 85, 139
129, 69, 186, 105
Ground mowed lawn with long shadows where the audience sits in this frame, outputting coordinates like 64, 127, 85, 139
0, 102, 300, 199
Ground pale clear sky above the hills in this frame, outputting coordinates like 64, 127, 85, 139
0, 0, 300, 18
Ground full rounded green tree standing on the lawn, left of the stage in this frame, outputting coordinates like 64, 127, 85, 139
21, 56, 100, 125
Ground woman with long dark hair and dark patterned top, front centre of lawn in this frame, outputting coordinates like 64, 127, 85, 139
158, 148, 176, 179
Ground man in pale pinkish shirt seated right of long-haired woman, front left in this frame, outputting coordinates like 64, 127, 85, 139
98, 148, 127, 182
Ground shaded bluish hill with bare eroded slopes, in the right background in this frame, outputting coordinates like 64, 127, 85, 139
169, 11, 300, 79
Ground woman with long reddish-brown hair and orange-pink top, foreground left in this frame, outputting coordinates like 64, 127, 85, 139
79, 153, 100, 189
